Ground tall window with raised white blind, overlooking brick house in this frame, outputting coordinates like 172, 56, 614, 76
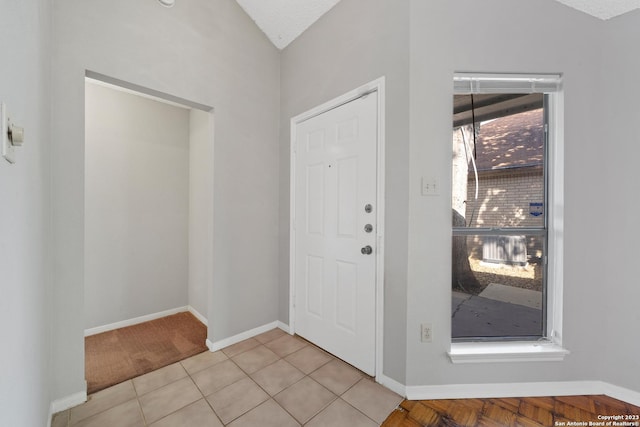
452, 74, 562, 344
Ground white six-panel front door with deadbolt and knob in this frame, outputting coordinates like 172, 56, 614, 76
292, 92, 378, 375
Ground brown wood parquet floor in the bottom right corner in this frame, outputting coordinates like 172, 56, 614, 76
382, 396, 640, 427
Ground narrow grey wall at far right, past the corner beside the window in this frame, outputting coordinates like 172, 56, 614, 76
600, 11, 640, 391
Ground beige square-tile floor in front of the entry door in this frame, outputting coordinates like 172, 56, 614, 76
52, 329, 402, 427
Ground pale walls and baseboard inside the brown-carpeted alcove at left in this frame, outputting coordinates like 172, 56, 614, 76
84, 72, 213, 388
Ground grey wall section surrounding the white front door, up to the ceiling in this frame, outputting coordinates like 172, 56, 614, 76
279, 0, 409, 383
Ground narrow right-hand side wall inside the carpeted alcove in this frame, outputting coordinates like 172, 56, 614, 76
188, 109, 213, 317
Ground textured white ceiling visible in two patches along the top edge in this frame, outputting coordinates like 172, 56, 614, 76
237, 0, 640, 49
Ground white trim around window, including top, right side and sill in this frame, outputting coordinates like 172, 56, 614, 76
447, 73, 569, 363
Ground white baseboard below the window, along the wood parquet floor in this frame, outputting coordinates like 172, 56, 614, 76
406, 381, 640, 406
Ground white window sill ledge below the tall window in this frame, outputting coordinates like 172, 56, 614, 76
447, 342, 569, 363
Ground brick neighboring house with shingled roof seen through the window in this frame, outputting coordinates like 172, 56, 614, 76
466, 109, 545, 264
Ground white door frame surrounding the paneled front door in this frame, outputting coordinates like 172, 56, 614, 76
289, 76, 385, 378
